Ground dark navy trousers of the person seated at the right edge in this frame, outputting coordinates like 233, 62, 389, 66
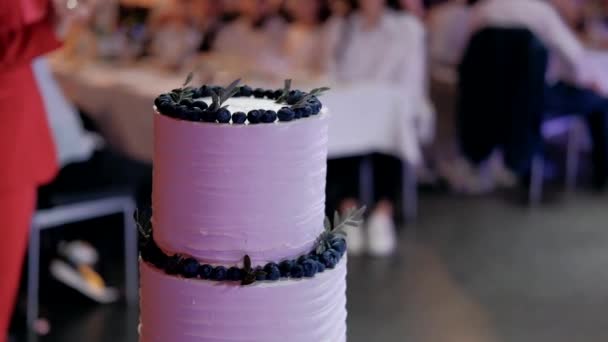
545, 83, 608, 188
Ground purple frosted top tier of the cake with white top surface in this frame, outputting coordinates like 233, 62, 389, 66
153, 98, 328, 265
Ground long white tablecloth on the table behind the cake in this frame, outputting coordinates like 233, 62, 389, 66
53, 61, 433, 164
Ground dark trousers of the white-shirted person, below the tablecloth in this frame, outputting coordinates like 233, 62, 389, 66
326, 153, 403, 217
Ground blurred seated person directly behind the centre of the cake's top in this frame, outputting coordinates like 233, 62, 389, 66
213, 0, 286, 58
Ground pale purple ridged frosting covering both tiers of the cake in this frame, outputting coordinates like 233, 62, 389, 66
140, 98, 346, 342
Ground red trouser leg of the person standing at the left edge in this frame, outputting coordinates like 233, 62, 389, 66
0, 185, 36, 341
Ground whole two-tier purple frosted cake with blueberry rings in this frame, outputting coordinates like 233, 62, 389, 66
140, 82, 360, 342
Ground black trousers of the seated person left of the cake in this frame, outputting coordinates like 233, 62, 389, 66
38, 148, 152, 207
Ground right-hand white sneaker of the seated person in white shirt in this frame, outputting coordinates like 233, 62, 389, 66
367, 213, 397, 256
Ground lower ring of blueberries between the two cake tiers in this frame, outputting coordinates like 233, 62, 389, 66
140, 227, 346, 285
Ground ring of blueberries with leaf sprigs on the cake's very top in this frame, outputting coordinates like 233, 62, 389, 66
154, 85, 323, 125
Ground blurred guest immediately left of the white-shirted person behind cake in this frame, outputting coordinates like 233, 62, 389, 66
284, 0, 327, 75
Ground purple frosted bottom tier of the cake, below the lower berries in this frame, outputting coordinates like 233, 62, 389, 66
139, 258, 346, 342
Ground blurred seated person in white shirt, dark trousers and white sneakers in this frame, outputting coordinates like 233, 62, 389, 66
328, 0, 432, 256
